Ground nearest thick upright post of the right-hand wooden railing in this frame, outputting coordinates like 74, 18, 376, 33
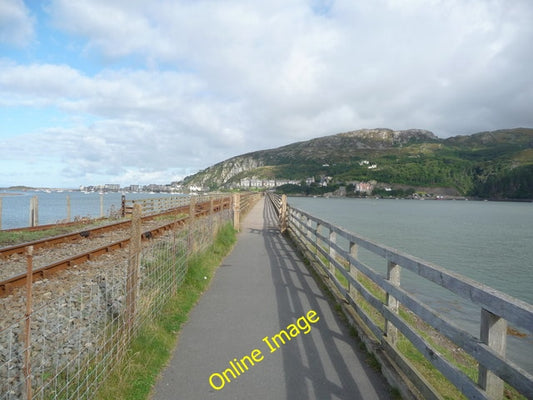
478, 308, 507, 399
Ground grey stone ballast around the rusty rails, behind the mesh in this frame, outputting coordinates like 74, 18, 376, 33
0, 224, 181, 400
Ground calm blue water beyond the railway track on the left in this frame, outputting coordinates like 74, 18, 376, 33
0, 191, 181, 229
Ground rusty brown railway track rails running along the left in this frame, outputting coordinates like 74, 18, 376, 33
0, 198, 231, 297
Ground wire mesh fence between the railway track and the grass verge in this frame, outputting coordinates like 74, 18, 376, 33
0, 210, 232, 400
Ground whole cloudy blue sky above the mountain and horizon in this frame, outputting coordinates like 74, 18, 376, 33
0, 0, 533, 188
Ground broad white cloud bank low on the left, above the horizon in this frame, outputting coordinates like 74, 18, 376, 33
0, 62, 244, 184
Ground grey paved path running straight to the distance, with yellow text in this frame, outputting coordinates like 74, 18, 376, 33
153, 201, 390, 400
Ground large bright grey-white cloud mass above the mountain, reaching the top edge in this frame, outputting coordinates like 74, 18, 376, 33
43, 0, 533, 138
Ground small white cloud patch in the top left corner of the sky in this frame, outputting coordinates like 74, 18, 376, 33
0, 0, 34, 46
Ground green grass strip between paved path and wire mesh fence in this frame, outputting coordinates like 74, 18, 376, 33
95, 224, 236, 400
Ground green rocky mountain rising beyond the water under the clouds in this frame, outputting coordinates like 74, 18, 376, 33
183, 128, 533, 199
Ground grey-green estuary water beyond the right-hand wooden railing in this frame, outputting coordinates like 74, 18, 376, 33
288, 197, 533, 373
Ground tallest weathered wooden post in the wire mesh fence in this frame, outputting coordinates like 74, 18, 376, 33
126, 204, 142, 332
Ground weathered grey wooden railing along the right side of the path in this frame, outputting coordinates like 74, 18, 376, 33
269, 194, 533, 399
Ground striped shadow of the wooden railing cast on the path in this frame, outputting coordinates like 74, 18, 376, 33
262, 201, 390, 400
